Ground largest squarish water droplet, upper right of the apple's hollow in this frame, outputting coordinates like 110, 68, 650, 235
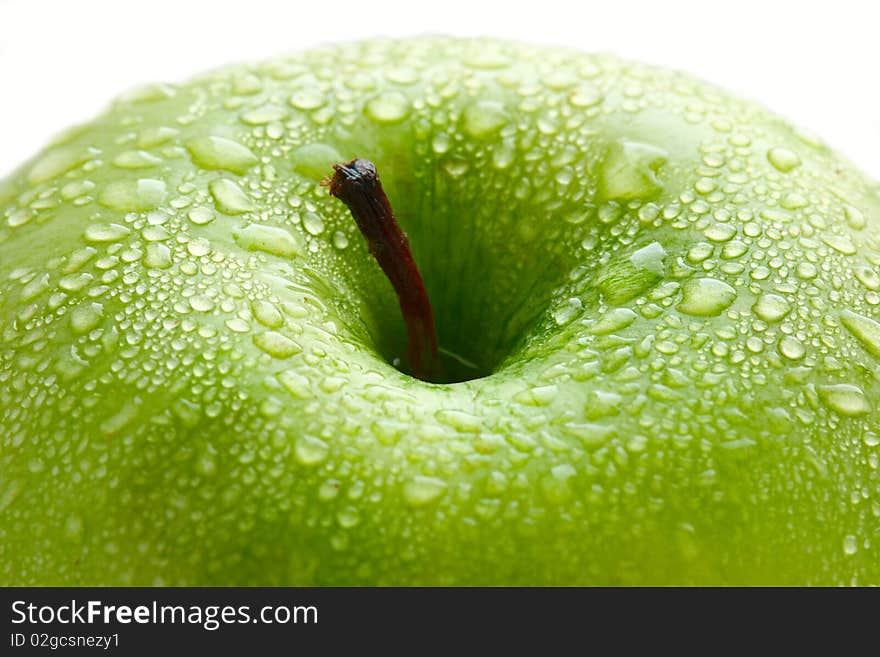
599, 139, 668, 200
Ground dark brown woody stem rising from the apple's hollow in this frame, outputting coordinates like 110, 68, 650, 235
322, 158, 441, 381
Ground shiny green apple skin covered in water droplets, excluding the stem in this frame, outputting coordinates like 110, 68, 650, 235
0, 38, 880, 585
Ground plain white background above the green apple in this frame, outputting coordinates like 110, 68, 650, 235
0, 0, 880, 178
